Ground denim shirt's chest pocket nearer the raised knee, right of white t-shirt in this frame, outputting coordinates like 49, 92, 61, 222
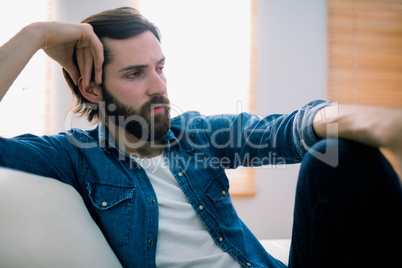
204, 171, 236, 227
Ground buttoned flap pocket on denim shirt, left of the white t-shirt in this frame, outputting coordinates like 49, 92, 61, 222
87, 182, 135, 247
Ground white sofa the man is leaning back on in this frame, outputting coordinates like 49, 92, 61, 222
0, 168, 290, 268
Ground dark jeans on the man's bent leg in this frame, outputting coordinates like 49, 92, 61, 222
289, 140, 402, 268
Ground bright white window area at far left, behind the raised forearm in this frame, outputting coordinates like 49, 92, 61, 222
0, 0, 48, 137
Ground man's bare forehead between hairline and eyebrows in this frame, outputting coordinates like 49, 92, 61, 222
106, 31, 163, 67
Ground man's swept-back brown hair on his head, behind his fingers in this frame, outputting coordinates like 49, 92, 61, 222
63, 7, 160, 122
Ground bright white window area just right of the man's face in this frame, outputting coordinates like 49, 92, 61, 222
139, 0, 250, 116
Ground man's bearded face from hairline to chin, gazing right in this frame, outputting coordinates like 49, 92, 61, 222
101, 31, 170, 141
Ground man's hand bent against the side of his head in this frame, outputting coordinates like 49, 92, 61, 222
33, 22, 104, 87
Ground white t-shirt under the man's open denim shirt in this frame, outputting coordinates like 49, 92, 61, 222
135, 152, 241, 268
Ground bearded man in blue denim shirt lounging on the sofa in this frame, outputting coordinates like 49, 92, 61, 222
0, 8, 402, 267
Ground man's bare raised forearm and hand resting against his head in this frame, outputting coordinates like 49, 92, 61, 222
0, 22, 103, 99
